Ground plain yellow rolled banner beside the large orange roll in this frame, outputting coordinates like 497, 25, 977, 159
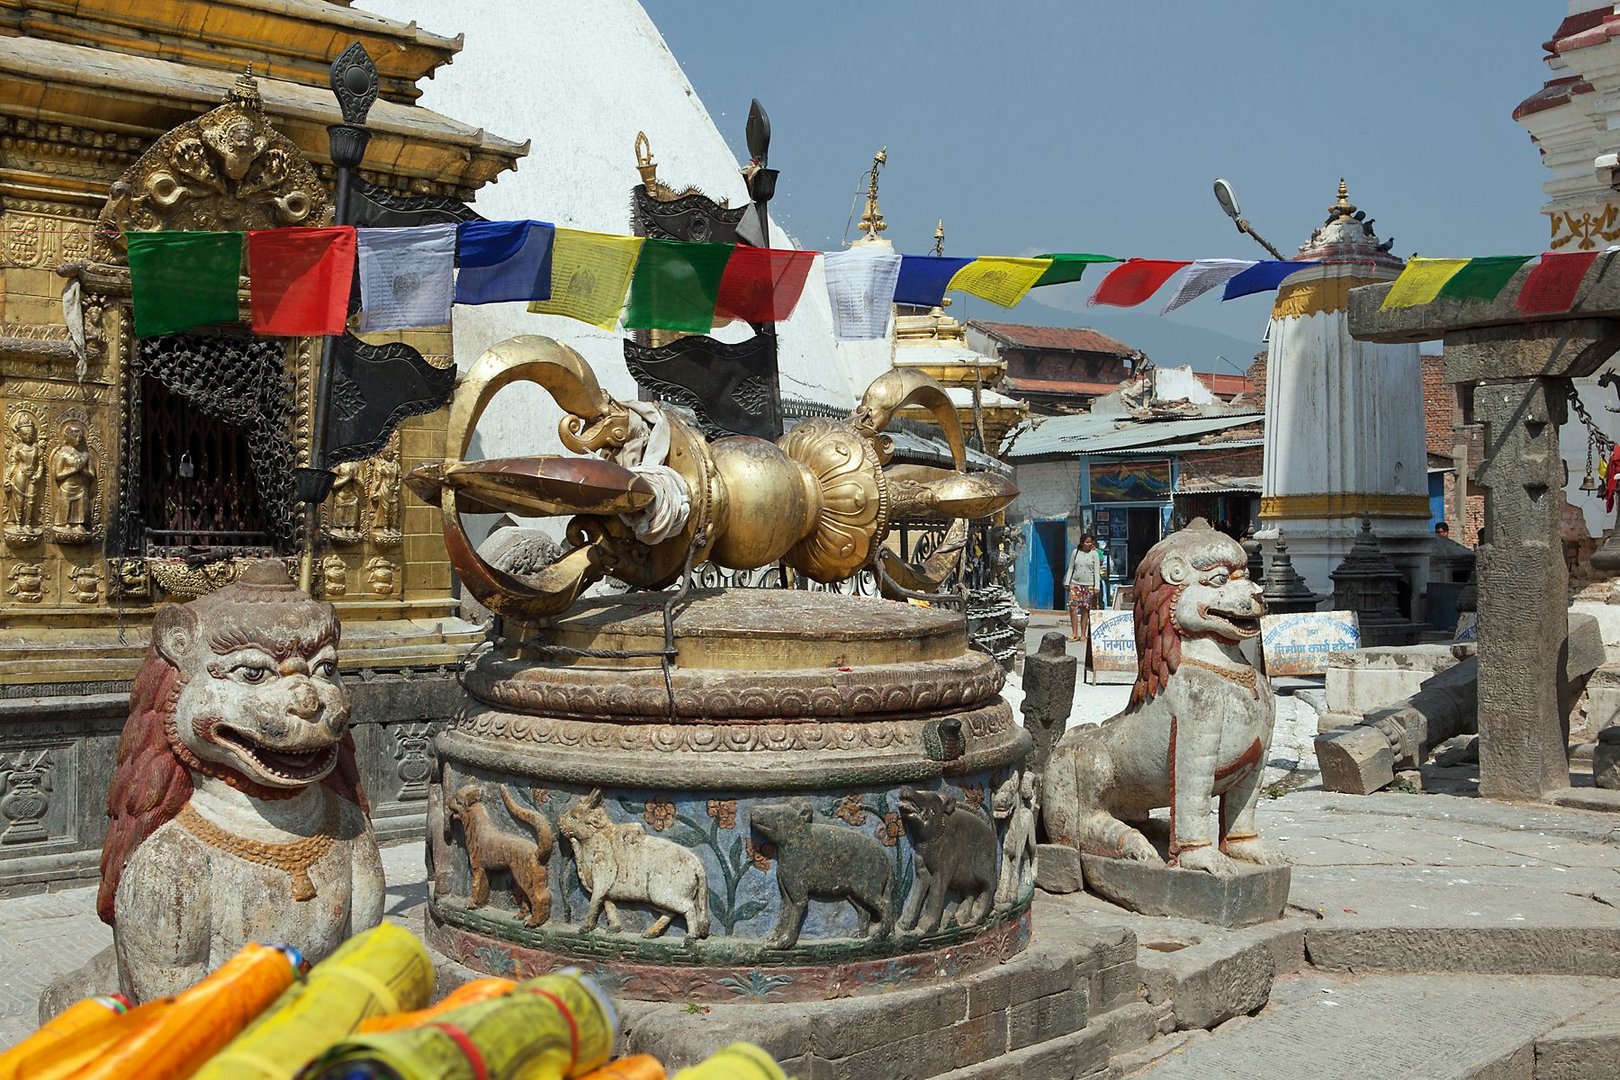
194, 923, 433, 1080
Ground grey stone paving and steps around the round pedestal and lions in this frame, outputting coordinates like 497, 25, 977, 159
9, 789, 1620, 1080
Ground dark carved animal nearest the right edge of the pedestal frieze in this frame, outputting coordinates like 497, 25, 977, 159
901, 787, 996, 934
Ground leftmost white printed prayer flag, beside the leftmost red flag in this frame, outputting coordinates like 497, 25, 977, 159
356, 222, 455, 330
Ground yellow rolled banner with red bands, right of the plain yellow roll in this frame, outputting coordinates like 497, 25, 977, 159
303, 973, 619, 1080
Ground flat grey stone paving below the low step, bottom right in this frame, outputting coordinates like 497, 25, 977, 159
1132, 975, 1620, 1080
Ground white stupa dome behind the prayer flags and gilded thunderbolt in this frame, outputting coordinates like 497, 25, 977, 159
360, 0, 889, 476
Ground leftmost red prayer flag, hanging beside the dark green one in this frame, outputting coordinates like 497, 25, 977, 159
248, 225, 355, 337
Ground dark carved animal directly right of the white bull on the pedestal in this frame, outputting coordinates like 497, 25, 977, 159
750, 798, 894, 949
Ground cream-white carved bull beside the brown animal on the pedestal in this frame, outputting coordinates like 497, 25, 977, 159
557, 790, 710, 942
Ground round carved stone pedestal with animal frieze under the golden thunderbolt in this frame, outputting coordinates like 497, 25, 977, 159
428, 589, 1034, 1001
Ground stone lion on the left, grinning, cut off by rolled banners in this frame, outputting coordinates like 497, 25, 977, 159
92, 560, 382, 1001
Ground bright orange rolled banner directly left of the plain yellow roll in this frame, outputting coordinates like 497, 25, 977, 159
71, 944, 296, 1080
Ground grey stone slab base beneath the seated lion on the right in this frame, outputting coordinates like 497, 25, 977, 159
1081, 853, 1290, 926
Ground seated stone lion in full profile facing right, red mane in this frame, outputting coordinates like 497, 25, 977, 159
1042, 518, 1275, 874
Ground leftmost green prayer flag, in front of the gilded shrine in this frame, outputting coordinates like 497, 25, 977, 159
125, 230, 241, 337
